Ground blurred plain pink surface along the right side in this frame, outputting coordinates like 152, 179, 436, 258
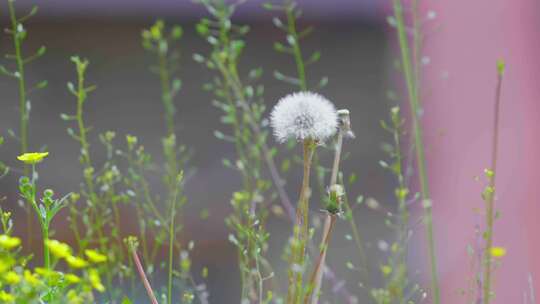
421, 0, 540, 304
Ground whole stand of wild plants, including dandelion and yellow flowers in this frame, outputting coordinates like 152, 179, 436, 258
0, 0, 516, 304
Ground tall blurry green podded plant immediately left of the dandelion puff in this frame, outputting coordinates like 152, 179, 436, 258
193, 0, 275, 302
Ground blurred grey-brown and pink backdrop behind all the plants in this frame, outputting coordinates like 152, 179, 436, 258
0, 0, 540, 303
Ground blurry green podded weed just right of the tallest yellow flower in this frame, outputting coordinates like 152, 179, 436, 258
61, 56, 129, 298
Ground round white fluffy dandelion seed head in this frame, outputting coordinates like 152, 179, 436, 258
270, 92, 338, 142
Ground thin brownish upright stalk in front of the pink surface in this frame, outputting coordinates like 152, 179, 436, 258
483, 61, 505, 304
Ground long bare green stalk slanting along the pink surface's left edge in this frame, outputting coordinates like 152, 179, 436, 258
393, 0, 441, 304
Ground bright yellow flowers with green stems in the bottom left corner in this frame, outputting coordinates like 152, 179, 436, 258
0, 156, 107, 304
